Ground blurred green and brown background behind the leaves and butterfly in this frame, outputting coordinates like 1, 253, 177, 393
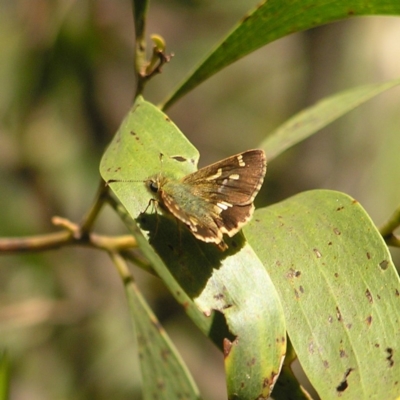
0, 0, 400, 400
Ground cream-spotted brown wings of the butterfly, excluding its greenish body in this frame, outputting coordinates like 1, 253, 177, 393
173, 150, 267, 249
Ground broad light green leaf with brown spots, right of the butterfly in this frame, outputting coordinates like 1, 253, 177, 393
245, 190, 400, 399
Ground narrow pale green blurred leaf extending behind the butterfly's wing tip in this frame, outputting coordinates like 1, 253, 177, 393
259, 79, 400, 161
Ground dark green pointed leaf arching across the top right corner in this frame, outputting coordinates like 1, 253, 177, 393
162, 0, 400, 109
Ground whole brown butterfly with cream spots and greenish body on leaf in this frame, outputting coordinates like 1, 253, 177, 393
147, 150, 266, 250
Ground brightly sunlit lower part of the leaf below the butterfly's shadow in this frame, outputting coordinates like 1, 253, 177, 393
196, 245, 286, 399
